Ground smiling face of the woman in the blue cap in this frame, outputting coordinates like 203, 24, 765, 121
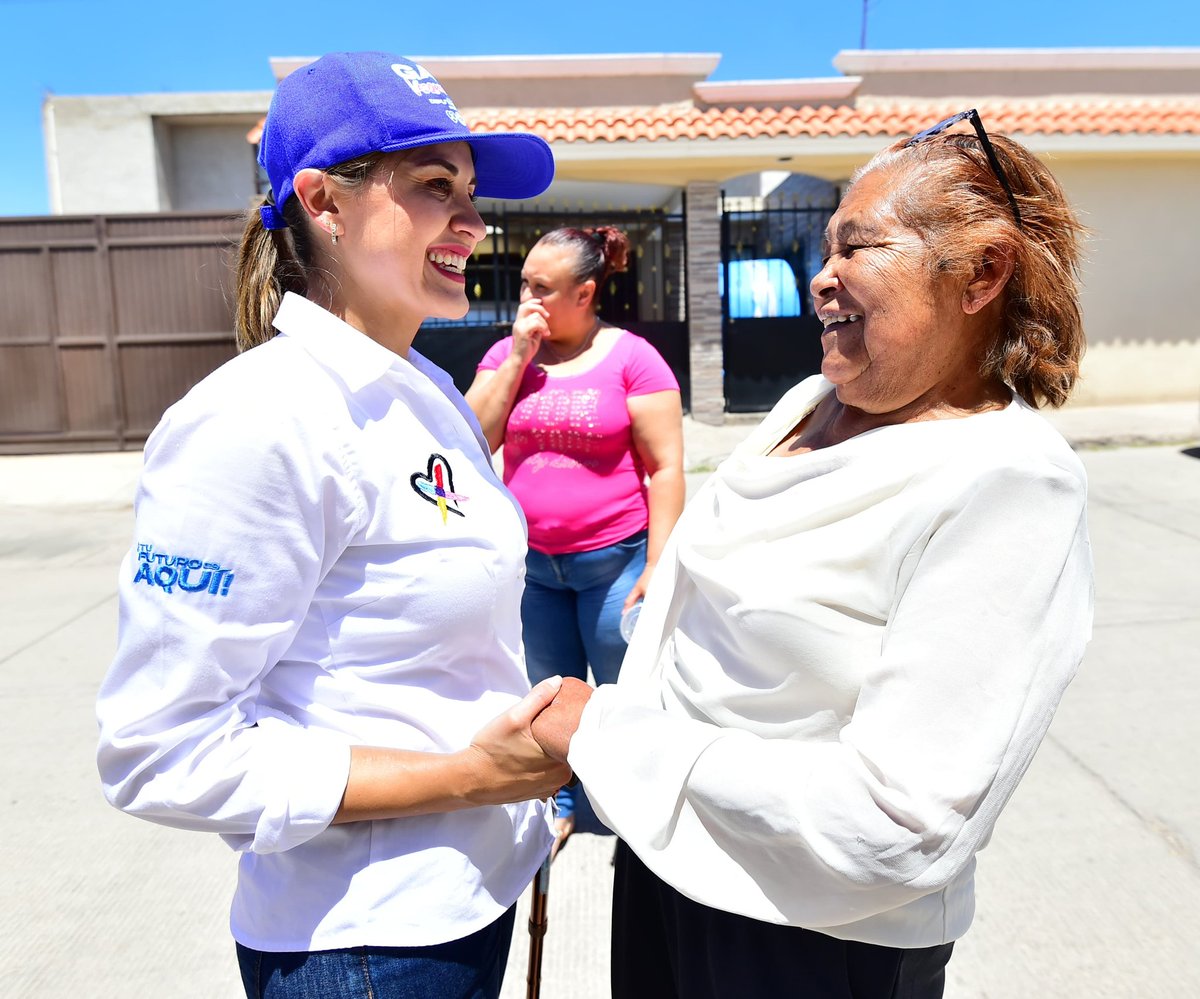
334, 142, 484, 335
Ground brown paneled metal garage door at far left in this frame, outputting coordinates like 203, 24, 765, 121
0, 213, 241, 454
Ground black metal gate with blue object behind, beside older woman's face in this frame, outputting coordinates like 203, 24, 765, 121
721, 196, 833, 413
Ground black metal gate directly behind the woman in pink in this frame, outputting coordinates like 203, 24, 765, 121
414, 204, 690, 407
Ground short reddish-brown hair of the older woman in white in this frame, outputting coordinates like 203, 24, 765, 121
851, 132, 1086, 406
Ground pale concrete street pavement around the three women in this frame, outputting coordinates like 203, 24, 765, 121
0, 414, 1200, 999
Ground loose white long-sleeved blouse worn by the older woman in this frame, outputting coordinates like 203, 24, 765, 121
570, 376, 1092, 947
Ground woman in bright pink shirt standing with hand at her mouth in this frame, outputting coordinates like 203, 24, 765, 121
467, 226, 684, 851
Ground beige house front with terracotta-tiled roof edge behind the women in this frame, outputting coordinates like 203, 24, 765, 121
43, 48, 1200, 421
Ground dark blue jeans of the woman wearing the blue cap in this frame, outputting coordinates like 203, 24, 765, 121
238, 902, 516, 999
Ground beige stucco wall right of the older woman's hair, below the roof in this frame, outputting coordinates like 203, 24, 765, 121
1049, 157, 1200, 405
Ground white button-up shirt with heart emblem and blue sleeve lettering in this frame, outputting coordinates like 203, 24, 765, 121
98, 294, 551, 951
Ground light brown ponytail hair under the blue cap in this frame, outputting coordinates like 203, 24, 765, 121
234, 152, 385, 351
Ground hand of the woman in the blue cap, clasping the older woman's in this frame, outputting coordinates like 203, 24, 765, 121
467, 676, 577, 804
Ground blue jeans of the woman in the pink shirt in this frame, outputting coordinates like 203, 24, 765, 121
521, 531, 646, 816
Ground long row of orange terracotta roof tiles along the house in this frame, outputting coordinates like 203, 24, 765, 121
468, 96, 1200, 142
